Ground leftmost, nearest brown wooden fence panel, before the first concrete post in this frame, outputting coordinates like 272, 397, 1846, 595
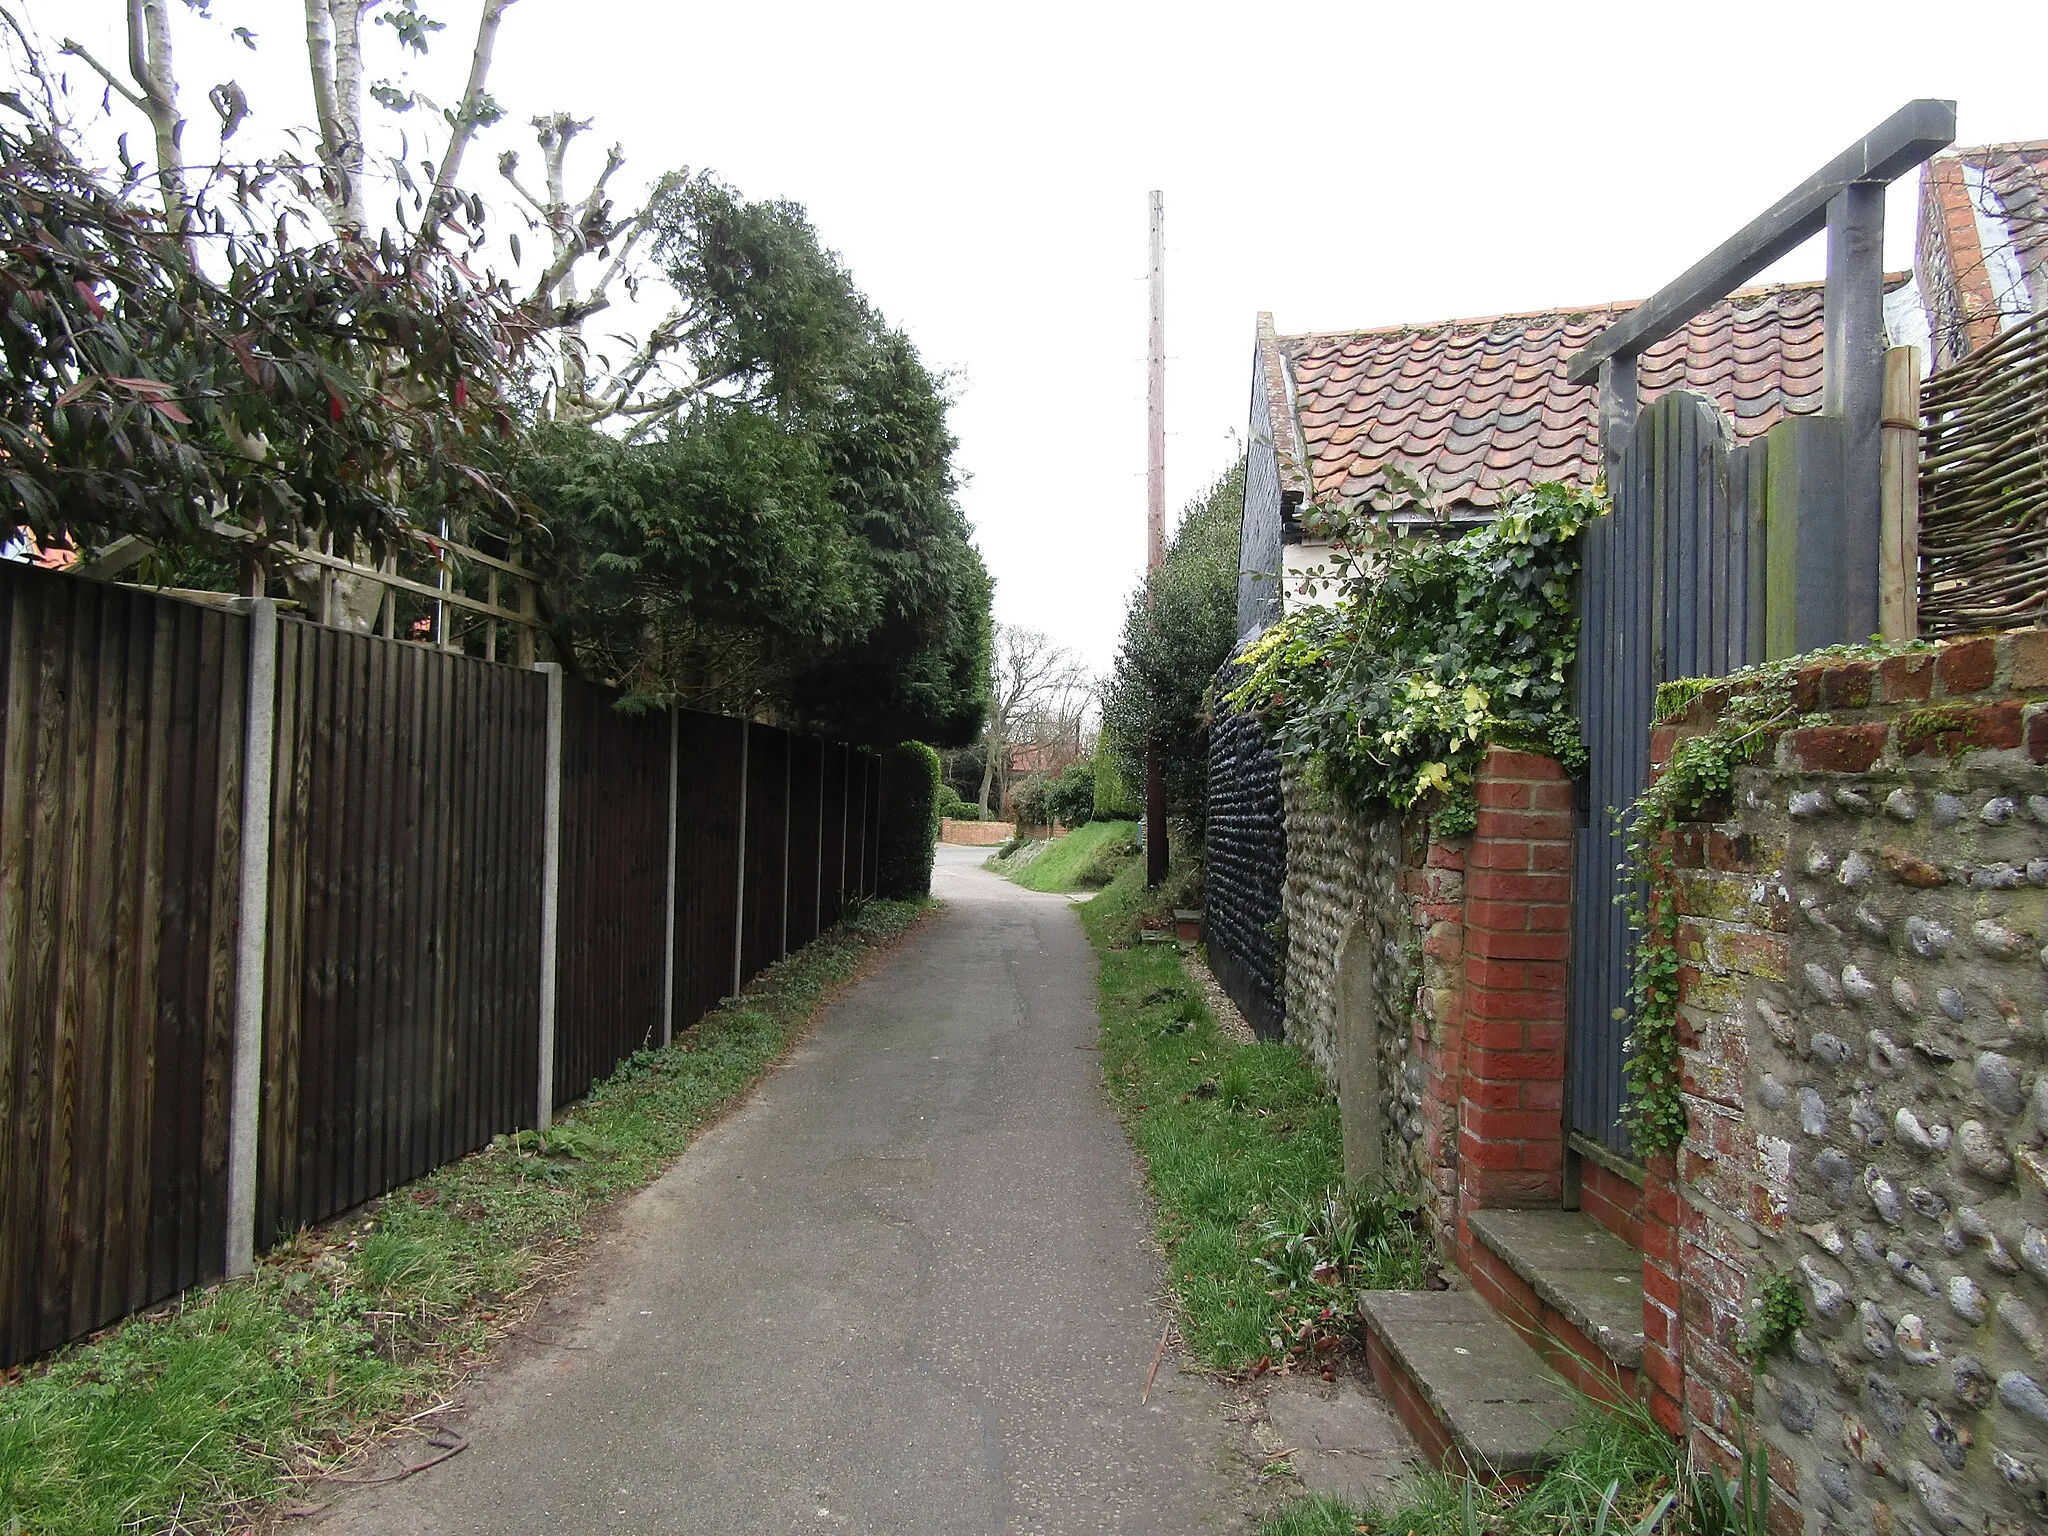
0, 565, 248, 1366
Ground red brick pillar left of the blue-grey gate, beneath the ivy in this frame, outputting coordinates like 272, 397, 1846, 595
1458, 748, 1571, 1257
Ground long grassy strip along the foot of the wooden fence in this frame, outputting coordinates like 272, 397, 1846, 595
0, 901, 924, 1536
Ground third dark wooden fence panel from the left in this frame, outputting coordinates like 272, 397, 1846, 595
555, 678, 668, 1106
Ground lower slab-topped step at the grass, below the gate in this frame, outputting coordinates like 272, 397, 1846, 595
1364, 1290, 1579, 1481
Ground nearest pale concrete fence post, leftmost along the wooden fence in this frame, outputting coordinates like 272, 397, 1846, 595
227, 598, 276, 1280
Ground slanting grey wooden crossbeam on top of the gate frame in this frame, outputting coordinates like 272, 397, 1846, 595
1565, 100, 1956, 383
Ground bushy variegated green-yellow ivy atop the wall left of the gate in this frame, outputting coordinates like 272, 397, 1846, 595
1227, 483, 1606, 836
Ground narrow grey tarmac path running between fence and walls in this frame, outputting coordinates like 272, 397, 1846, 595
309, 848, 1245, 1536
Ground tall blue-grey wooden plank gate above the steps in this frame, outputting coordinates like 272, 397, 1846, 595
1567, 391, 1778, 1157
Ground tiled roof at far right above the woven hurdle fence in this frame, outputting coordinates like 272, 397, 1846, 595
1913, 139, 2048, 369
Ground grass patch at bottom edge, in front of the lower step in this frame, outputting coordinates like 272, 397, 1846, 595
1260, 1405, 1695, 1536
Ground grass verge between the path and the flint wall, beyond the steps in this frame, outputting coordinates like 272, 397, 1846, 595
1081, 862, 1425, 1370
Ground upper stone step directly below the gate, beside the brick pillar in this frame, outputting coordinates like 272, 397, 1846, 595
1466, 1210, 1642, 1370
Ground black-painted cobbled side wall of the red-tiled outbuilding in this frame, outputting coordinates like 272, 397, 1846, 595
1202, 711, 1288, 1038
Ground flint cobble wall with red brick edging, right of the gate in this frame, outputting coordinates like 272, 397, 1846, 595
1642, 631, 2048, 1532
